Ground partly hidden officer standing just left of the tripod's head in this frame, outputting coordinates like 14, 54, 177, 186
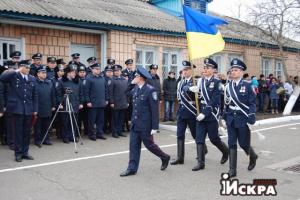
52, 63, 65, 139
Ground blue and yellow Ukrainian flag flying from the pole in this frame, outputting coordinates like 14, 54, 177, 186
183, 5, 227, 60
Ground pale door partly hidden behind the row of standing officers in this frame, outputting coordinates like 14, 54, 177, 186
71, 44, 96, 65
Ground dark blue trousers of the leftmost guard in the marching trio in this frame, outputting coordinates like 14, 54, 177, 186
177, 116, 196, 140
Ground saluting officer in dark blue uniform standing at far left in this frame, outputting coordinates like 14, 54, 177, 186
0, 60, 38, 162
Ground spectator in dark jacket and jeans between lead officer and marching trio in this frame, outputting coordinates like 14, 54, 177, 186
163, 71, 177, 121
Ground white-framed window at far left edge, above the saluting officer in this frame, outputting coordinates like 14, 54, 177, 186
0, 38, 24, 65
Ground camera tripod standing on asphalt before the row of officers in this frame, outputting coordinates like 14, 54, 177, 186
40, 90, 83, 153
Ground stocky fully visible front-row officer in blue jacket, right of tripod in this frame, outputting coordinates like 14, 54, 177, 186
85, 63, 109, 141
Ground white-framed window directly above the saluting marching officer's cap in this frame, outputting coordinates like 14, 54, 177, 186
135, 47, 156, 69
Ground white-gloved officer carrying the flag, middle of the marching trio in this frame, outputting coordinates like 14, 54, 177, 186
189, 58, 228, 171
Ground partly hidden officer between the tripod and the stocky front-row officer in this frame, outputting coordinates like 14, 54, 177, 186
77, 65, 89, 135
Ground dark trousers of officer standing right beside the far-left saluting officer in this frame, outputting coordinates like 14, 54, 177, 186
34, 117, 51, 144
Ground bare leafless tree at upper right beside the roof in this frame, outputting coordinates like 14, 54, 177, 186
248, 0, 300, 83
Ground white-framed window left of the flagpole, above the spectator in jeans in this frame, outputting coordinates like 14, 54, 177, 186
162, 51, 178, 78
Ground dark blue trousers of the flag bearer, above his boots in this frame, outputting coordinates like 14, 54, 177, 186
196, 120, 221, 146
